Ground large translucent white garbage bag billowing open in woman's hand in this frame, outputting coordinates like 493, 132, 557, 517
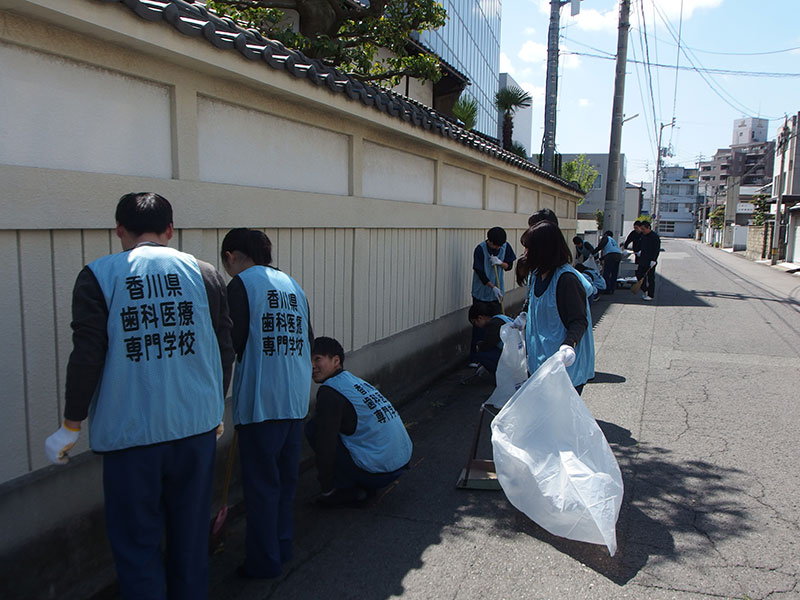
492, 355, 623, 556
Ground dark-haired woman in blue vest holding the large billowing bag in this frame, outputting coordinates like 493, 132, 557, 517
516, 222, 594, 394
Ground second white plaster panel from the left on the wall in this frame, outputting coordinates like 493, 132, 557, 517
197, 97, 350, 196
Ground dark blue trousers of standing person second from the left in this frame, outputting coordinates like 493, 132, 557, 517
238, 419, 303, 577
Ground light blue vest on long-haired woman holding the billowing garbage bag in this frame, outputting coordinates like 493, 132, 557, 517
525, 265, 594, 386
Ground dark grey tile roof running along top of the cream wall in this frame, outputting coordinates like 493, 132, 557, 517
102, 0, 580, 191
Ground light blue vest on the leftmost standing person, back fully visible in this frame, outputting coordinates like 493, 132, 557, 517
89, 244, 224, 452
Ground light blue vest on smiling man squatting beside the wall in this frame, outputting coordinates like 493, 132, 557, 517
322, 371, 412, 473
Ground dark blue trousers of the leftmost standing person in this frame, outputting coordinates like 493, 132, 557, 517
103, 431, 216, 600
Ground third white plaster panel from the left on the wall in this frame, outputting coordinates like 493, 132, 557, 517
363, 141, 435, 204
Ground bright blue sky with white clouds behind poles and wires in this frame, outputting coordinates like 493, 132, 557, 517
500, 0, 800, 182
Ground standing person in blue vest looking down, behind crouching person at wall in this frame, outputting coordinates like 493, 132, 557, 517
469, 227, 517, 367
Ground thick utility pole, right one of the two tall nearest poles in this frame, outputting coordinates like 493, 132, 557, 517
603, 0, 631, 236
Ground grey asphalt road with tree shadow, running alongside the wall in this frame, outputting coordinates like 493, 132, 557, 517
206, 240, 800, 600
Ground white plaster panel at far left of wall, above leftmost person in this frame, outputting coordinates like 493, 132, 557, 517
0, 44, 172, 178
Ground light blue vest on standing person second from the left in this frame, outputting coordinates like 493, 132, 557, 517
233, 265, 311, 425
